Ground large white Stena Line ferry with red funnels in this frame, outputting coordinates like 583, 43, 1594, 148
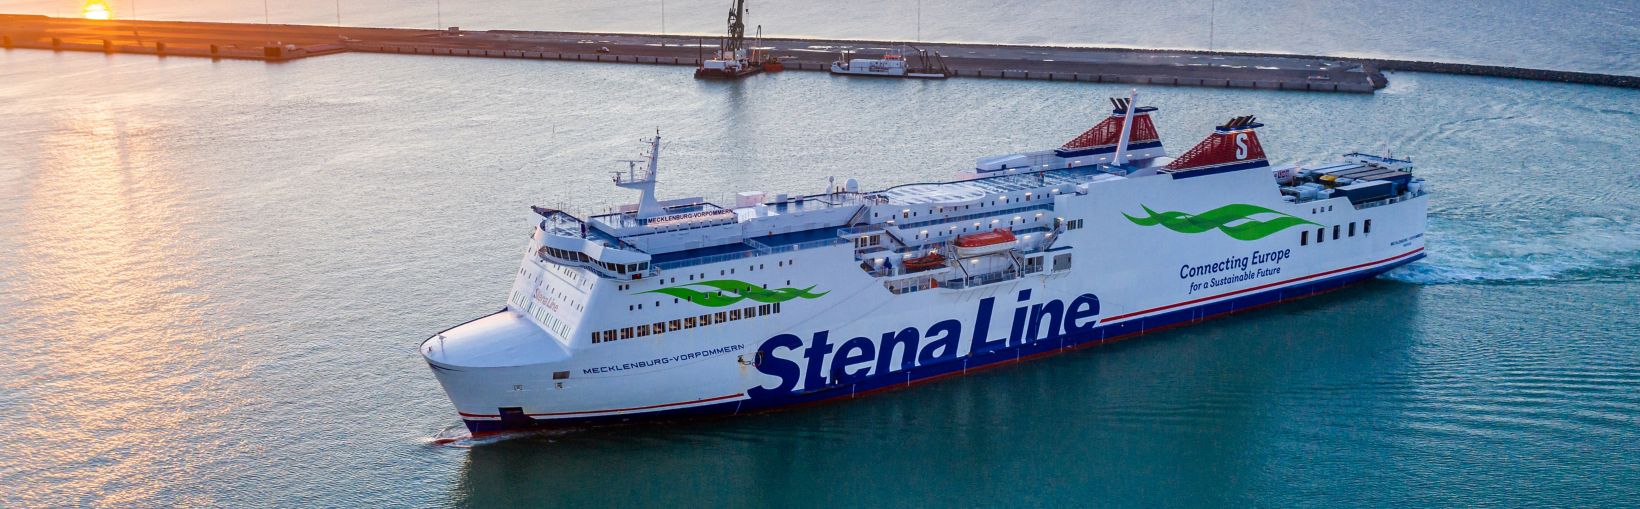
420, 94, 1427, 435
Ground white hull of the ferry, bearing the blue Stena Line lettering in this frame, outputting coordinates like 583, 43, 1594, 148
421, 160, 1425, 432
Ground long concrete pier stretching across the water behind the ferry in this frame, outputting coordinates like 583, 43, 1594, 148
0, 15, 1640, 94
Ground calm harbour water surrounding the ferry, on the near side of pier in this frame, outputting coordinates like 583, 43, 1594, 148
0, 17, 1640, 507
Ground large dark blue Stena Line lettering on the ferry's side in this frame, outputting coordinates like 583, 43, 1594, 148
746, 289, 1099, 399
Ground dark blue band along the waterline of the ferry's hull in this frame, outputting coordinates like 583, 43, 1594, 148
466, 250, 1424, 433
